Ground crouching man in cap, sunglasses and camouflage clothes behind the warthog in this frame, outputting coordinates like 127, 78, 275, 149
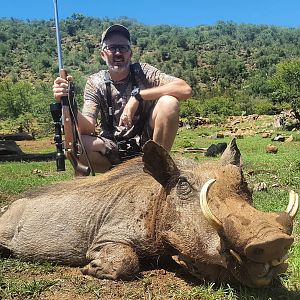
53, 24, 192, 172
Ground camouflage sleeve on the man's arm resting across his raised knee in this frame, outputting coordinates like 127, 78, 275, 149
141, 63, 177, 87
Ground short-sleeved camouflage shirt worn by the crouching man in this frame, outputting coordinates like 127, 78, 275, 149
82, 63, 175, 142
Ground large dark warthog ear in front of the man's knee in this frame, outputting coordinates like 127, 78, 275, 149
143, 140, 180, 187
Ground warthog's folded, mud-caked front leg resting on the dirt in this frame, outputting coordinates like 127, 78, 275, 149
81, 244, 139, 280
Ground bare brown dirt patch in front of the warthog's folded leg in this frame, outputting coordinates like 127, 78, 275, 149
45, 269, 197, 300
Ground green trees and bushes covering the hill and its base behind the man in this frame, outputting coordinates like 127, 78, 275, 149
0, 14, 300, 133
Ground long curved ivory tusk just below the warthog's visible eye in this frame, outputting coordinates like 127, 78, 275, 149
200, 179, 223, 231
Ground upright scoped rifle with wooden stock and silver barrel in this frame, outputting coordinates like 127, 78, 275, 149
50, 0, 95, 176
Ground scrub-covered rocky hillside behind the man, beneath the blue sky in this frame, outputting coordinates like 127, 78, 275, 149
0, 14, 300, 88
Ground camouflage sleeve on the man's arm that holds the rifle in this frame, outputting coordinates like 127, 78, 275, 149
82, 76, 101, 119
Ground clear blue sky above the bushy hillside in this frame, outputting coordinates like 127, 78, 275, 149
0, 0, 300, 27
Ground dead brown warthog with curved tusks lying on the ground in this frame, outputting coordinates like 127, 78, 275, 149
0, 140, 298, 287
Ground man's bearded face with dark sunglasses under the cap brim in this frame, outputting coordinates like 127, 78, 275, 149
101, 33, 132, 73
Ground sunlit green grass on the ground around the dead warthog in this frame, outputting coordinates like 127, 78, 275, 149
0, 120, 300, 300
